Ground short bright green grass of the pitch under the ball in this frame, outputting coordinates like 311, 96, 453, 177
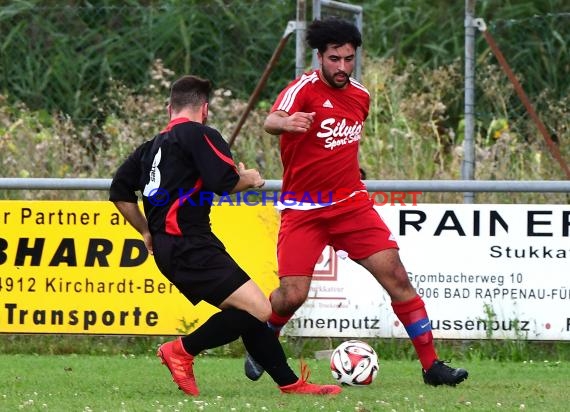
0, 354, 570, 412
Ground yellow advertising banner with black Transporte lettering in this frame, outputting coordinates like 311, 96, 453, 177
0, 201, 278, 335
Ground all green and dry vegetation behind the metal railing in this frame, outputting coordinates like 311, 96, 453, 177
0, 0, 570, 203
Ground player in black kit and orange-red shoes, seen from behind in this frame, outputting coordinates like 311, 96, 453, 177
109, 75, 341, 396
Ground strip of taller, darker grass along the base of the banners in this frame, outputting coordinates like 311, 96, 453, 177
0, 330, 570, 362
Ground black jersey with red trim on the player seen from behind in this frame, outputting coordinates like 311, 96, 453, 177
109, 118, 239, 236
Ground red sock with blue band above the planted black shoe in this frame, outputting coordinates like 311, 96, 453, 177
392, 295, 437, 370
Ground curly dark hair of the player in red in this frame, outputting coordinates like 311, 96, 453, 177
306, 17, 362, 54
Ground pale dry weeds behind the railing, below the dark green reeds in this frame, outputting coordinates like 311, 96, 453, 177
0, 59, 570, 203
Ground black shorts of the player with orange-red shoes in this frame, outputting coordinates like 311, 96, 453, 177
152, 233, 250, 307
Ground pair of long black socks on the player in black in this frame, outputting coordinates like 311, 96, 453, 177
182, 309, 298, 386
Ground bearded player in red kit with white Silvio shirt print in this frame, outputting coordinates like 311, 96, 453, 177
245, 18, 468, 386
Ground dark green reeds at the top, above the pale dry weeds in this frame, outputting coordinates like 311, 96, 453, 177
0, 0, 570, 112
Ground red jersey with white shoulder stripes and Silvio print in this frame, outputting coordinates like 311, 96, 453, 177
271, 70, 370, 202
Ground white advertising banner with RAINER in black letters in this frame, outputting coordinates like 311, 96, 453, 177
285, 204, 570, 340
